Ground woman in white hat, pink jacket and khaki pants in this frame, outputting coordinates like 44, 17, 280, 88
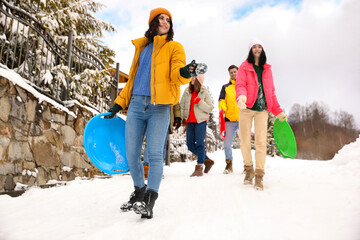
235, 38, 286, 190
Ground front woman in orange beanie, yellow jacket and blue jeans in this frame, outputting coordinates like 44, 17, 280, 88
106, 8, 202, 218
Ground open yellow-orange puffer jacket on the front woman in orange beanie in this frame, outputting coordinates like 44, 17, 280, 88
115, 34, 191, 109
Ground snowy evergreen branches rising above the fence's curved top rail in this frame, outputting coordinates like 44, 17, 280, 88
15, 0, 116, 66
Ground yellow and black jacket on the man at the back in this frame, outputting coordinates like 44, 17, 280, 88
219, 79, 239, 122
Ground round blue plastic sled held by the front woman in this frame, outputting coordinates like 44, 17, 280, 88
84, 112, 129, 175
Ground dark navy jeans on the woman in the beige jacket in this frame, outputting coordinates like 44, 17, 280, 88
186, 121, 207, 164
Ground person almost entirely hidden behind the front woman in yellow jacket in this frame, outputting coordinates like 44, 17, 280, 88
143, 103, 181, 179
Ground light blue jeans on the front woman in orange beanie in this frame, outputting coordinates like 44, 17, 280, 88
125, 95, 170, 192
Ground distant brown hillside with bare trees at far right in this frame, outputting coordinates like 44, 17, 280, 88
288, 102, 360, 160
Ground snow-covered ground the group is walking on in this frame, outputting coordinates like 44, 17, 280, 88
0, 138, 360, 240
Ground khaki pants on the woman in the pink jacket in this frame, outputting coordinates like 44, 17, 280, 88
239, 109, 268, 171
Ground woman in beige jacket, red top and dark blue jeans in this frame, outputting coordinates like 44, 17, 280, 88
180, 74, 214, 177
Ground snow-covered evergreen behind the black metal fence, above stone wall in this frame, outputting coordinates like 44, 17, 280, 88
0, 0, 115, 108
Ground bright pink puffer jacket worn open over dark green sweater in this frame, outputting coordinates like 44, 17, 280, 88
235, 60, 282, 116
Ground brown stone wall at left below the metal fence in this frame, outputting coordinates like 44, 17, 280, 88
0, 76, 102, 192
